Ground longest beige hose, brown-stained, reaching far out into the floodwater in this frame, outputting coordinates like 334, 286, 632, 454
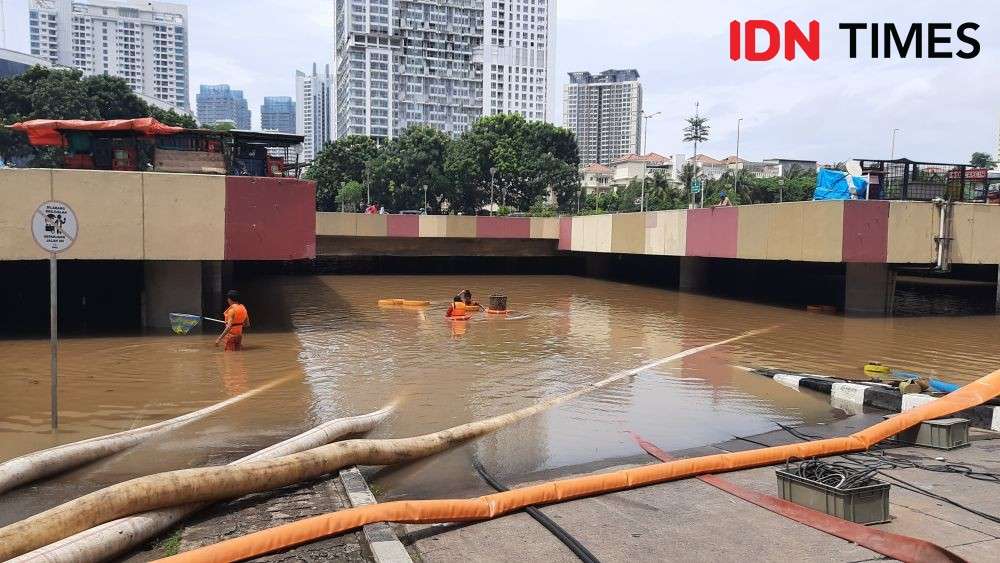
0, 331, 763, 560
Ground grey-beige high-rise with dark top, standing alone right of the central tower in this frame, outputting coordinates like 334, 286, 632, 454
563, 69, 644, 165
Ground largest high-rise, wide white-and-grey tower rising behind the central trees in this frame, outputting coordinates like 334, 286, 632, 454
334, 0, 555, 137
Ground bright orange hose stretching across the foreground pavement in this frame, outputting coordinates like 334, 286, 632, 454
156, 370, 1000, 563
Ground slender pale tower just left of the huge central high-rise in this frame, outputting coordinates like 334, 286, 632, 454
295, 63, 333, 162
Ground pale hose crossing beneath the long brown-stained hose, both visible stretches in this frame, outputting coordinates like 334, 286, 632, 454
11, 405, 394, 563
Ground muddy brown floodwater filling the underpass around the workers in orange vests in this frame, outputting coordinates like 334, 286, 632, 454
0, 276, 1000, 523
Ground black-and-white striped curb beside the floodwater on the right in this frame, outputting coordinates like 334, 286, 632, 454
746, 368, 1000, 432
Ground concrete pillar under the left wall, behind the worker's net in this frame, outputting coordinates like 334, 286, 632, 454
142, 260, 202, 328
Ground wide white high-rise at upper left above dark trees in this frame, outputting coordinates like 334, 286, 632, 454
28, 0, 190, 110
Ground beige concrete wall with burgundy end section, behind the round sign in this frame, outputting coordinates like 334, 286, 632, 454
0, 169, 317, 261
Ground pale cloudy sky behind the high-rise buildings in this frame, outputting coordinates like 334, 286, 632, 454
0, 0, 1000, 162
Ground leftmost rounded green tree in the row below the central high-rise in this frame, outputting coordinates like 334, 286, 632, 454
305, 135, 378, 211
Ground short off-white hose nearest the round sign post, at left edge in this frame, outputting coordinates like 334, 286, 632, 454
0, 376, 293, 494
